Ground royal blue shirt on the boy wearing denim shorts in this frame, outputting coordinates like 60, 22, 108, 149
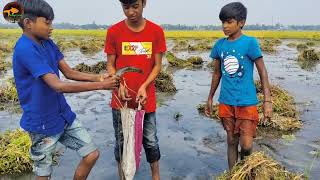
13, 35, 76, 135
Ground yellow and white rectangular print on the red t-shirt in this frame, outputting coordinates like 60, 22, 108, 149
122, 42, 152, 57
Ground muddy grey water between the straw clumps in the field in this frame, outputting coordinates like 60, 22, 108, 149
0, 41, 320, 180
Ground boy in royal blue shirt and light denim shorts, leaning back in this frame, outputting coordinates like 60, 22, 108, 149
13, 0, 118, 180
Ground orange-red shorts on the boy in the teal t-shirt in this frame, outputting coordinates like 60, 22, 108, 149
219, 104, 259, 137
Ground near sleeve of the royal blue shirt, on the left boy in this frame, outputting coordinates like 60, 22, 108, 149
17, 50, 54, 78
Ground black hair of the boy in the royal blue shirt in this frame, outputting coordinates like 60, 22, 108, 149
17, 0, 54, 29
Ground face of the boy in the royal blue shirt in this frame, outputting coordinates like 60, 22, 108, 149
25, 17, 53, 40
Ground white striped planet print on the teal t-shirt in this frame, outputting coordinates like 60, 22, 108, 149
221, 50, 244, 77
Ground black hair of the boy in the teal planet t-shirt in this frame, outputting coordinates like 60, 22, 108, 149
219, 2, 247, 22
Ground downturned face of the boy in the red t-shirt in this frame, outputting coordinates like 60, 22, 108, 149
122, 0, 146, 23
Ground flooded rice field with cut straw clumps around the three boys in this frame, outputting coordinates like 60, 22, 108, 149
0, 29, 320, 180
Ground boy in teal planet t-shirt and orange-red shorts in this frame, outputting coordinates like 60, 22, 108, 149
206, 2, 272, 169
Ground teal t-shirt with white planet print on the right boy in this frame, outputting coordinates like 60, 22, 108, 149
210, 35, 262, 106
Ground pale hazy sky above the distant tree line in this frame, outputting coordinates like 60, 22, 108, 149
0, 0, 320, 25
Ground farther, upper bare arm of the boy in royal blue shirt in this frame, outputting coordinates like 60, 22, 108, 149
59, 59, 103, 82
